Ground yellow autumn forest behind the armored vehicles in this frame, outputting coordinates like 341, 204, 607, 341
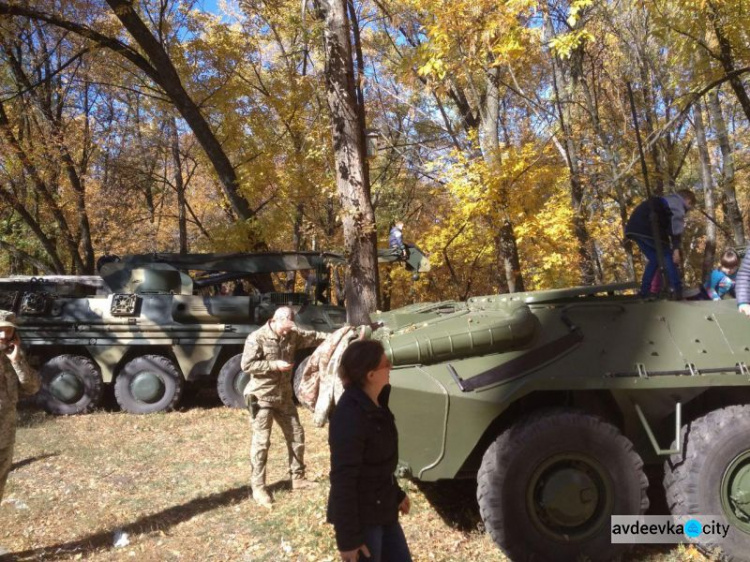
0, 0, 750, 308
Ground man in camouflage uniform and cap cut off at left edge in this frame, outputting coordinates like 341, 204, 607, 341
0, 310, 40, 500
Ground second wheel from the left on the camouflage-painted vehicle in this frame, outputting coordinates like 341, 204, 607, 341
115, 355, 184, 414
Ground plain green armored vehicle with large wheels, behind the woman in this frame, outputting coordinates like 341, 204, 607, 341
352, 285, 750, 561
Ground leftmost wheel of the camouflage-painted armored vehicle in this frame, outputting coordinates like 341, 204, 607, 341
37, 355, 102, 415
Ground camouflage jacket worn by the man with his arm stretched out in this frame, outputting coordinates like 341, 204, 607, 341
240, 323, 328, 402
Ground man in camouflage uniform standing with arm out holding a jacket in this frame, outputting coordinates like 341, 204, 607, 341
241, 307, 328, 508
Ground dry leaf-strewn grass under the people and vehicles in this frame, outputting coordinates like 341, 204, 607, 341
0, 399, 707, 562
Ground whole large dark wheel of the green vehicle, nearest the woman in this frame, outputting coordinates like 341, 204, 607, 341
477, 409, 648, 562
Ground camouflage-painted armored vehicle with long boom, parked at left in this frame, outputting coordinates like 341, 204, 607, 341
0, 249, 428, 414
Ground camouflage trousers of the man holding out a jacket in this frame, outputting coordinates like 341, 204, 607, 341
246, 397, 305, 489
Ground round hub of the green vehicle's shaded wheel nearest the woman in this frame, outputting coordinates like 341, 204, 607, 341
527, 454, 612, 540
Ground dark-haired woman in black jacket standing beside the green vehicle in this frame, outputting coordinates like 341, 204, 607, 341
328, 340, 411, 562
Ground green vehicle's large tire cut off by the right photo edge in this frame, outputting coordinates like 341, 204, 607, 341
664, 406, 750, 561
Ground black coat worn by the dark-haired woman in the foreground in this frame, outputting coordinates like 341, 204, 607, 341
328, 385, 406, 551
